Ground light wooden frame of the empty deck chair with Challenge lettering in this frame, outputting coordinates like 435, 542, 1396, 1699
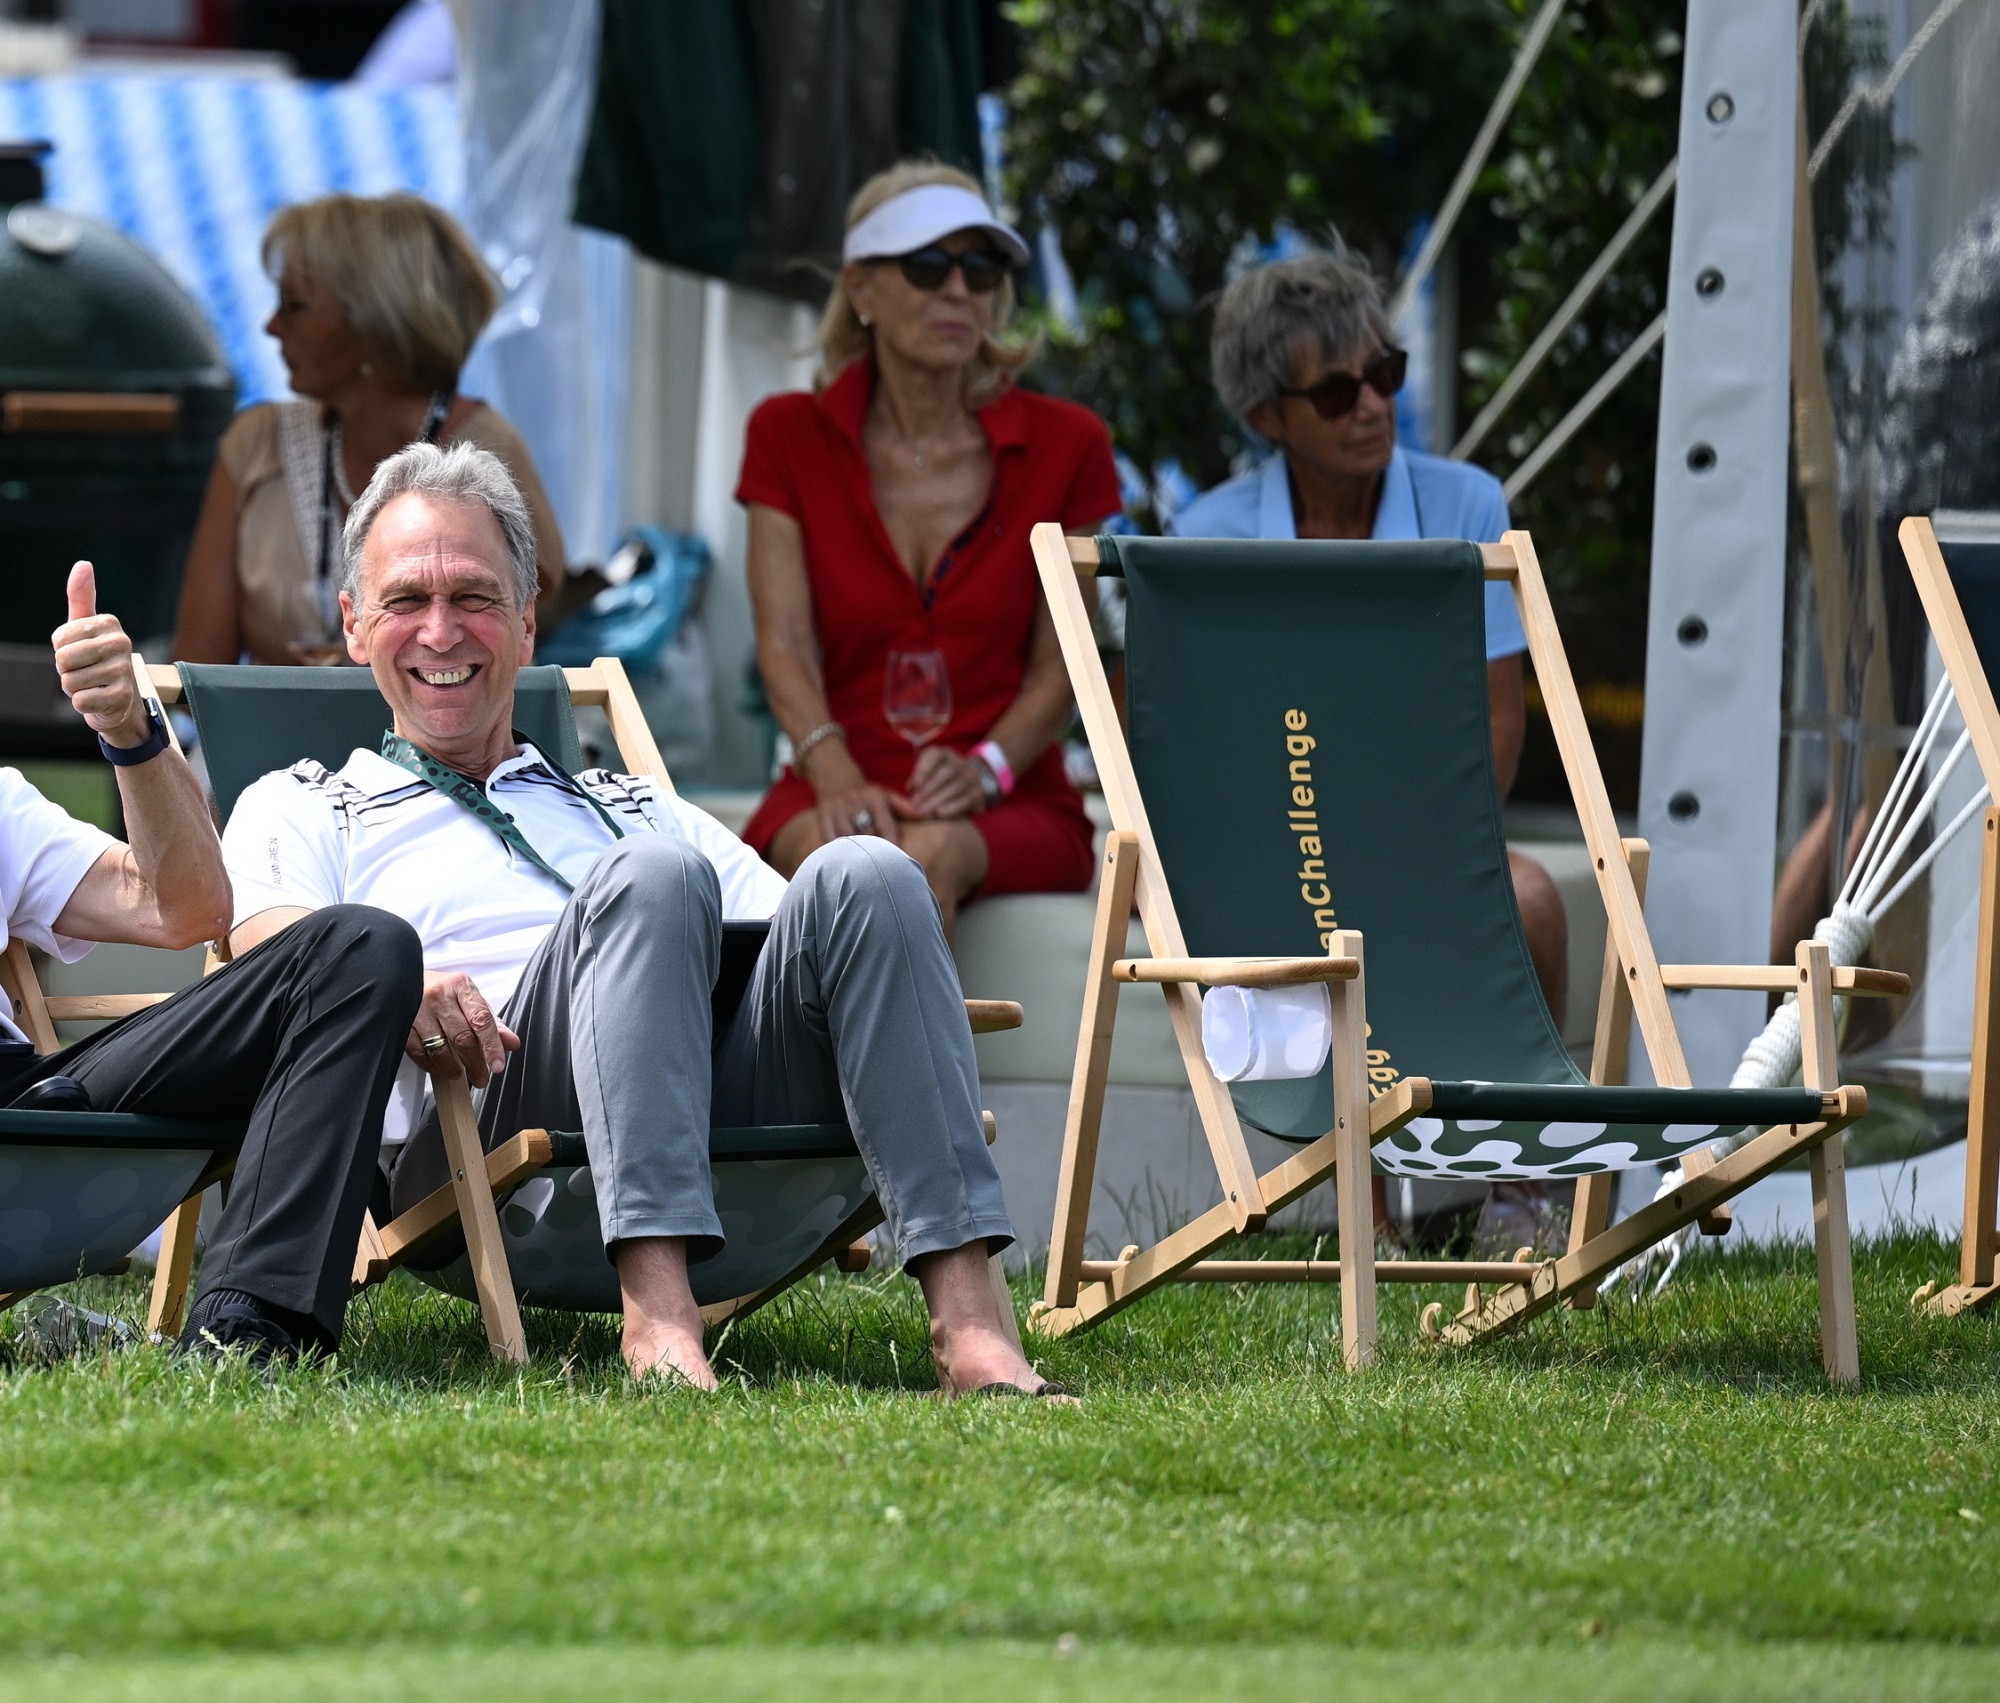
1030, 524, 1910, 1385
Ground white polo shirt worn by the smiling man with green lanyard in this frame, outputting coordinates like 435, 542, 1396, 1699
222, 746, 784, 1141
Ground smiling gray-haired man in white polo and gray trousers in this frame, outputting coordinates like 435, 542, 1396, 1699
224, 444, 1048, 1393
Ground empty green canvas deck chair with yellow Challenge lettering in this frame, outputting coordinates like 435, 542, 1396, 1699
1034, 526, 1880, 1383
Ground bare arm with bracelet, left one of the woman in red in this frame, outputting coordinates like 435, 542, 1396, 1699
750, 502, 912, 844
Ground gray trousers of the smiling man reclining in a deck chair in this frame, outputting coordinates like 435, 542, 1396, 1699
392, 834, 1014, 1259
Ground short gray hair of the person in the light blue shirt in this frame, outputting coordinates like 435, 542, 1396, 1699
1208, 244, 1394, 422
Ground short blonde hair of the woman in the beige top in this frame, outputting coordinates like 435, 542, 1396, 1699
264, 194, 500, 390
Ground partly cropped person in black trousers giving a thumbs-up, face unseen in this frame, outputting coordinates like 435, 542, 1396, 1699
0, 562, 420, 1361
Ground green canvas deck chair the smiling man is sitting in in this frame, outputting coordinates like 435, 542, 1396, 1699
152, 658, 1020, 1361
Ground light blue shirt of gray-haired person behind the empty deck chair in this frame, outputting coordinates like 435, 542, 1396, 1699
1166, 446, 1528, 662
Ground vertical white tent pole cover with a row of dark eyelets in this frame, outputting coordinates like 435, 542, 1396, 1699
1640, 0, 1798, 1083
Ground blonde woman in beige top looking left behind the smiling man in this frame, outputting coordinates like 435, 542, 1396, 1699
174, 196, 566, 664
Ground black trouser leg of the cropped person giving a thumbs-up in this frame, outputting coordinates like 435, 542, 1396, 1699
48, 905, 424, 1347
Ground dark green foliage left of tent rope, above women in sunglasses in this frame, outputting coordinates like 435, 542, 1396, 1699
1008, 0, 1514, 519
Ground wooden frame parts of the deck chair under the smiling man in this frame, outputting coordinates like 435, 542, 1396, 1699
127, 658, 1022, 1365
